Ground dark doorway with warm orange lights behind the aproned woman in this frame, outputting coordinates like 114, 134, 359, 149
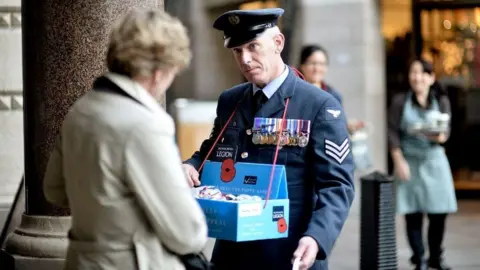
412, 0, 480, 194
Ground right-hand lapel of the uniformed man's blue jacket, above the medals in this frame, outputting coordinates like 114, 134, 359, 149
255, 68, 297, 118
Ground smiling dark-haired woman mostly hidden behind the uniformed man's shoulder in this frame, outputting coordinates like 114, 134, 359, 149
299, 45, 365, 134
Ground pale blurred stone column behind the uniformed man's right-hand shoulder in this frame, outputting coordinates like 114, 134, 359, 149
292, 0, 387, 171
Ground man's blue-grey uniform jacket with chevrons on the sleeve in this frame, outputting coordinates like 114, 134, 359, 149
185, 66, 354, 270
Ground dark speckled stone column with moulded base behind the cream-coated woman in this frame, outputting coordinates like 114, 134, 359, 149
1, 0, 163, 269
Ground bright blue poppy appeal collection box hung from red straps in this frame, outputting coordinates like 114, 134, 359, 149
198, 161, 290, 242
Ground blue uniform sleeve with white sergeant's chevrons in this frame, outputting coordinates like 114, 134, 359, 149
305, 98, 355, 260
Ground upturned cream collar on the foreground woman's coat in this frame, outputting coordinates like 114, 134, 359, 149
104, 72, 162, 113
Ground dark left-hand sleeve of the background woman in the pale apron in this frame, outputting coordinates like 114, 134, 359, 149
387, 95, 405, 150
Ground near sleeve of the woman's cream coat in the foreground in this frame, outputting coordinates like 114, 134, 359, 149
125, 123, 207, 255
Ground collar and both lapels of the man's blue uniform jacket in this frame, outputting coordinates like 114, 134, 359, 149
239, 67, 299, 126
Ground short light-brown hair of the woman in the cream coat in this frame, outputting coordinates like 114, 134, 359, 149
107, 9, 191, 77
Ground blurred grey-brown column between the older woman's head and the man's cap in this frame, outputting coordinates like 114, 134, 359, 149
165, 0, 243, 101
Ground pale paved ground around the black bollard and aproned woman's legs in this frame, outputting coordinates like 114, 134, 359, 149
202, 179, 480, 270
